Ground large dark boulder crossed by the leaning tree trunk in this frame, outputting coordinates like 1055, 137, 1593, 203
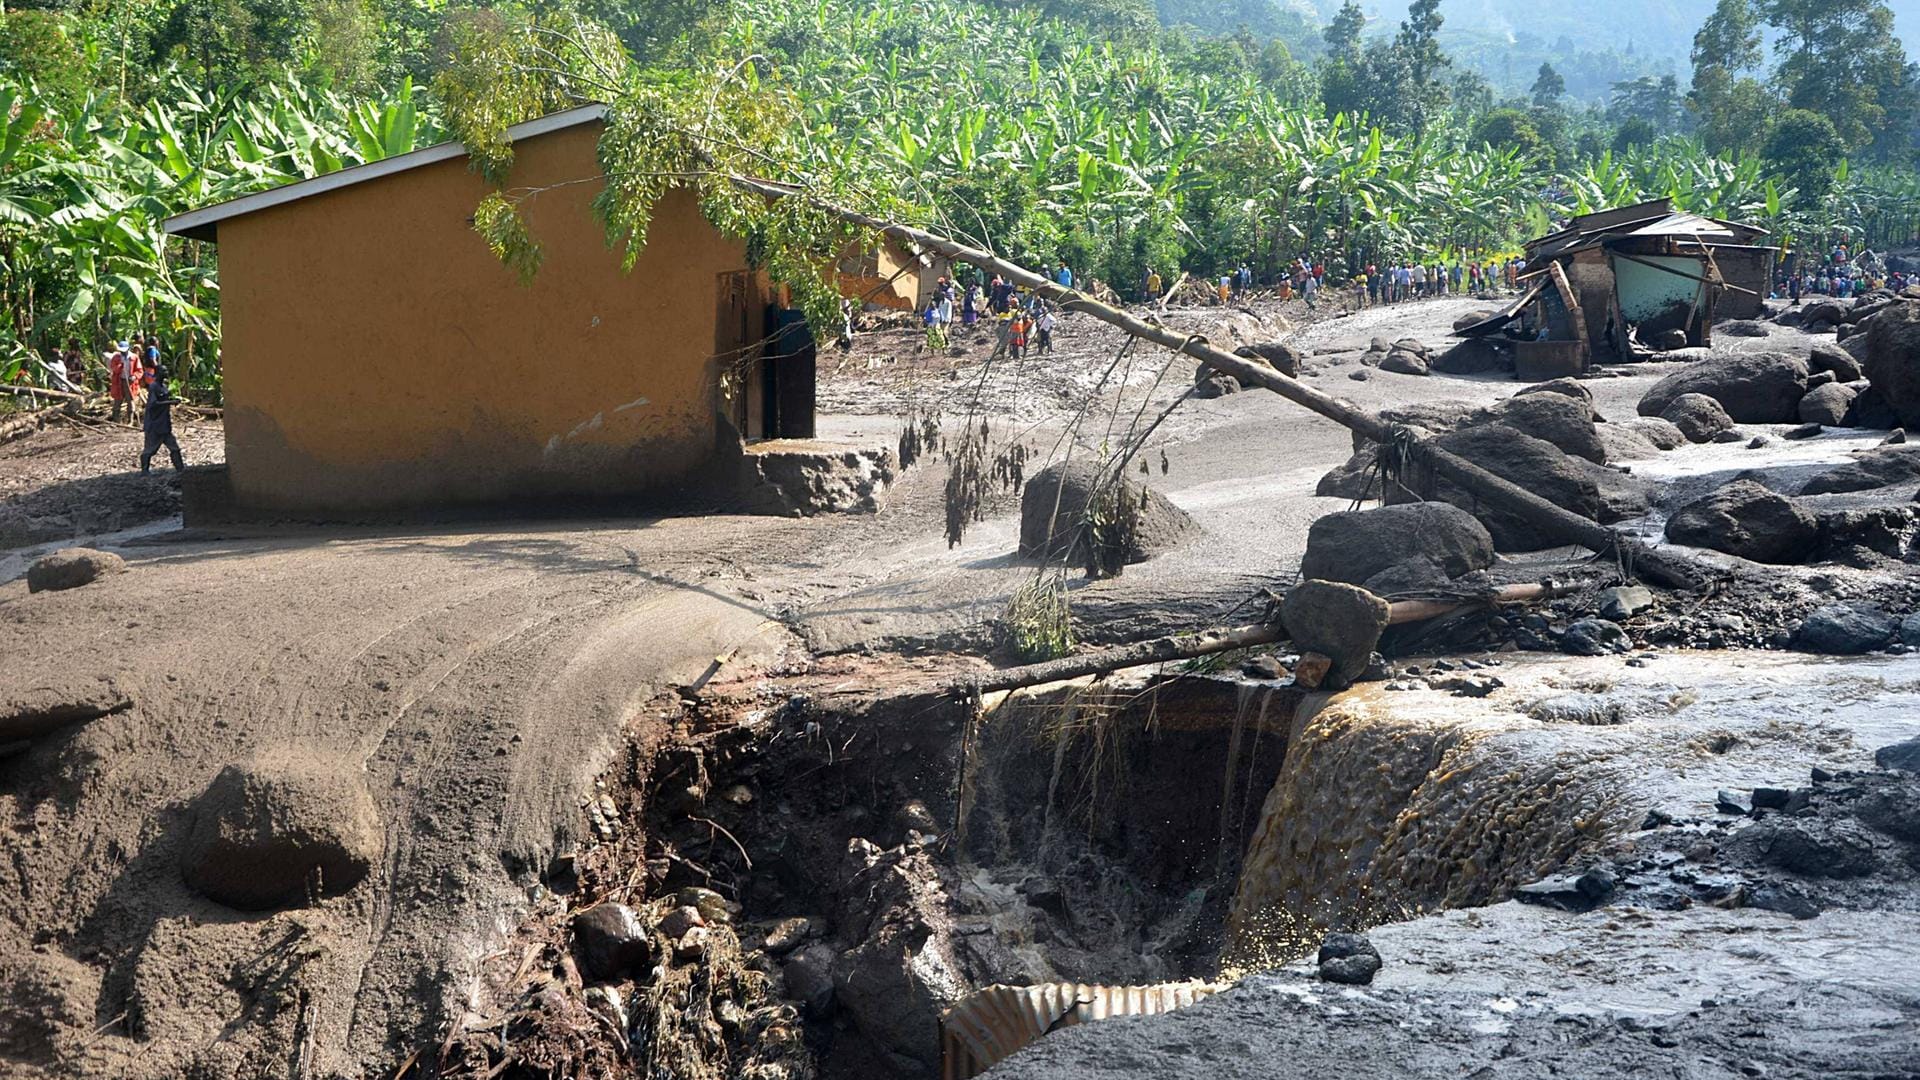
1386, 425, 1611, 552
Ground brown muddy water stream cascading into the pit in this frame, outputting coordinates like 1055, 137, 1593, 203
1231, 653, 1920, 967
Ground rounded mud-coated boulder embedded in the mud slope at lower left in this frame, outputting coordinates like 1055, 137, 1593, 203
180, 751, 382, 911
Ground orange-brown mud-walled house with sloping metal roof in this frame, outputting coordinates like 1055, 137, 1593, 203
167, 106, 814, 515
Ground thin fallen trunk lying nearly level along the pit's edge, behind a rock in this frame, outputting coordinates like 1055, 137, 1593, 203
947, 584, 1569, 694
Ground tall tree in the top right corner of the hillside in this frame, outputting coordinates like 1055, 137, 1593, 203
1763, 0, 1916, 160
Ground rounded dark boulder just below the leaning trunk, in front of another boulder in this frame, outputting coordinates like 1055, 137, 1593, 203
1300, 502, 1494, 584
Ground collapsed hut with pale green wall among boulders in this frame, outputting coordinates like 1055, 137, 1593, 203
1461, 200, 1778, 380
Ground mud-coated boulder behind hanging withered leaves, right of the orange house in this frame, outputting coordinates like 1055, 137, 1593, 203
1020, 459, 1194, 563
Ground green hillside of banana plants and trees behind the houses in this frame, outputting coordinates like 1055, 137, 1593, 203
0, 0, 1916, 394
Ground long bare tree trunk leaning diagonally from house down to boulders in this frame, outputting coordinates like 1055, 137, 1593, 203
733, 177, 1720, 590
